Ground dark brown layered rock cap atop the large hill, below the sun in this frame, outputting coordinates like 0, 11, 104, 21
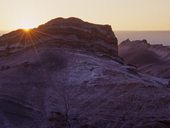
0, 18, 118, 57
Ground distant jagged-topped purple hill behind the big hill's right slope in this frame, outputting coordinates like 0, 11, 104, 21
119, 40, 170, 79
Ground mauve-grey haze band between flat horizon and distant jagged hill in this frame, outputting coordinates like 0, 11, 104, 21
115, 31, 170, 45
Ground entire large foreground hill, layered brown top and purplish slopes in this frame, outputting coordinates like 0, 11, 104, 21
0, 18, 170, 128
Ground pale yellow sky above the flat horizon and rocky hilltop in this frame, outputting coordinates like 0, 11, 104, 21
0, 0, 170, 31
